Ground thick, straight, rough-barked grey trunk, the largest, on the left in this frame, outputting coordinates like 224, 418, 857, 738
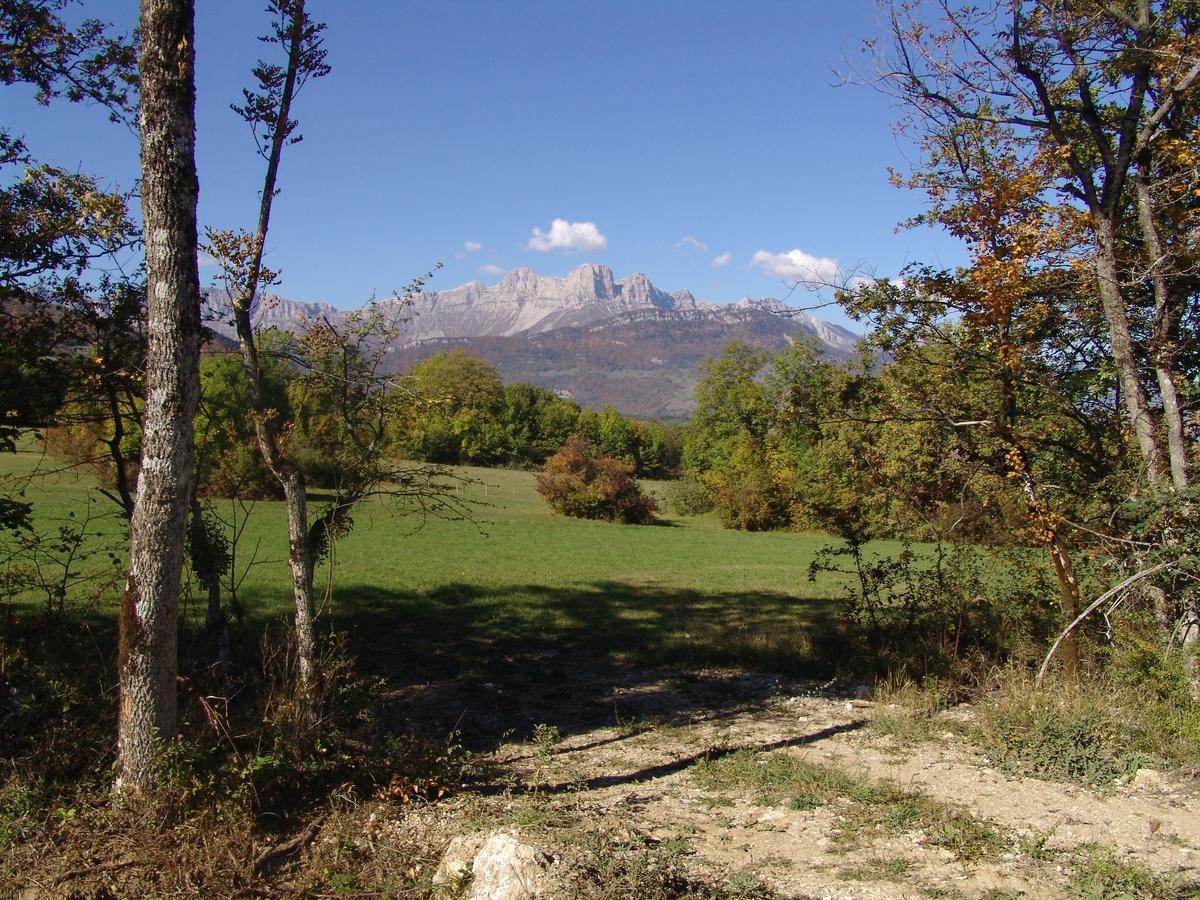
116, 0, 200, 797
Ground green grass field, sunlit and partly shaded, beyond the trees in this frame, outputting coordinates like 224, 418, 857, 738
0, 442, 902, 677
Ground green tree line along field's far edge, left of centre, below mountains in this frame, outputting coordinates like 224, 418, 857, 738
48, 345, 684, 499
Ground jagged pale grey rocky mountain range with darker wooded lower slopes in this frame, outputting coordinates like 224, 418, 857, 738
204, 263, 858, 418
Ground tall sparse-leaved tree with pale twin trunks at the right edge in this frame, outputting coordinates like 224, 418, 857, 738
883, 0, 1200, 491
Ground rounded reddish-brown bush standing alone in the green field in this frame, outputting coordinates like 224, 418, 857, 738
538, 438, 658, 524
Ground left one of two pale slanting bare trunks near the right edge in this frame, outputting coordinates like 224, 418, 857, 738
1092, 211, 1164, 487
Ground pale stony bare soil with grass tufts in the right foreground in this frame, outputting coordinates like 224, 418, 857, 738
386, 659, 1200, 898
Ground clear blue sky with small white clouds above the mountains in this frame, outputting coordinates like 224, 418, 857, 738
0, 0, 962, 331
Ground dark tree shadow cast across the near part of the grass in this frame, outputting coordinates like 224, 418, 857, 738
321, 581, 847, 748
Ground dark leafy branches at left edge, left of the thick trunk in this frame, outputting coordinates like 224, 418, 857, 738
0, 0, 138, 441
